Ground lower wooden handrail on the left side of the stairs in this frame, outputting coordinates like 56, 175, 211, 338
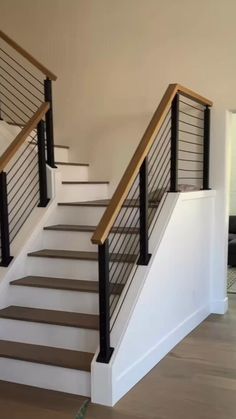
0, 102, 50, 172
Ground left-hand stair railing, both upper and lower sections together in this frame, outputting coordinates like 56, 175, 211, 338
0, 31, 57, 266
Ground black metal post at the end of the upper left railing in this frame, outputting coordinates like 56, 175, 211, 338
44, 78, 55, 168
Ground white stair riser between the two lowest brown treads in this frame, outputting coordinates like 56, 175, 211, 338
0, 319, 99, 352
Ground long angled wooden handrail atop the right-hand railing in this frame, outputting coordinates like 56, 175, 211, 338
91, 84, 213, 245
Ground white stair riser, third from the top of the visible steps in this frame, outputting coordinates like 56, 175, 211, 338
58, 183, 108, 202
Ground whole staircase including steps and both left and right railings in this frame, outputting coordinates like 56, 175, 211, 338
0, 31, 212, 405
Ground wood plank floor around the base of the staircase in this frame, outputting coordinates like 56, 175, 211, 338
0, 295, 236, 419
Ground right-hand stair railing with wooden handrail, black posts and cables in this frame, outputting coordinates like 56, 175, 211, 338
92, 84, 212, 363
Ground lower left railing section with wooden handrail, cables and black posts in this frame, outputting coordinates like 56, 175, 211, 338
0, 103, 49, 266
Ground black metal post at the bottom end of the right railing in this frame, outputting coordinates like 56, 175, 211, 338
97, 239, 114, 364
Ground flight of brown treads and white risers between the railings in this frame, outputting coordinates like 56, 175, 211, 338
0, 146, 113, 396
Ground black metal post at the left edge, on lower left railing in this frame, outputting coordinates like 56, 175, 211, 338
0, 172, 13, 266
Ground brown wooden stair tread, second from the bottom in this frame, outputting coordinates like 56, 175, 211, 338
0, 306, 99, 330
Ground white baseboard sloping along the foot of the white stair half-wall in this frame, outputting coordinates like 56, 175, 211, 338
112, 305, 210, 405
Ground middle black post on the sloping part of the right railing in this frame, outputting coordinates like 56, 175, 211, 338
137, 157, 151, 265
